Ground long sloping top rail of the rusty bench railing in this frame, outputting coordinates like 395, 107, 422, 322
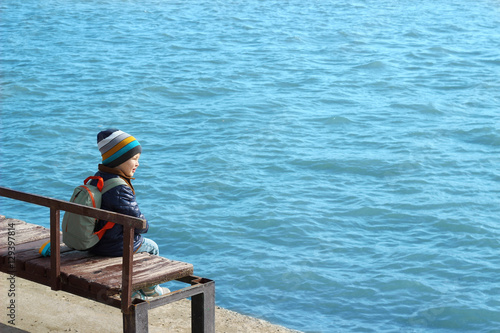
0, 186, 146, 229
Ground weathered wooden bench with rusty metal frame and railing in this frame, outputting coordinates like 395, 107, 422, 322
0, 186, 215, 333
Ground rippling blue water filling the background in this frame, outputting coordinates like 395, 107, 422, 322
0, 0, 500, 333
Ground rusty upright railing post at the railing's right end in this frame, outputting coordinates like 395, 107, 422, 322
122, 226, 134, 314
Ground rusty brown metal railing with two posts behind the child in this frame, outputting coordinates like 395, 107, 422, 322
0, 186, 146, 314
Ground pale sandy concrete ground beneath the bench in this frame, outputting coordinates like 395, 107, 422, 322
0, 273, 297, 333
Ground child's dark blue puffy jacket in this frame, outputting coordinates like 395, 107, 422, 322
89, 171, 149, 257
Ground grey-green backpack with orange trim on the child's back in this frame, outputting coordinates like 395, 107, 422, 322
62, 176, 127, 250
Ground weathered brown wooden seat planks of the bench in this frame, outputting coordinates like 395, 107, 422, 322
0, 218, 193, 296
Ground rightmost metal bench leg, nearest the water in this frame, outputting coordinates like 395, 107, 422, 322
191, 281, 215, 333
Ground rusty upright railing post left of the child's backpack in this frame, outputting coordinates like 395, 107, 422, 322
50, 207, 61, 290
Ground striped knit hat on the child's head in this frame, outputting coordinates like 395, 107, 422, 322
97, 128, 142, 168
